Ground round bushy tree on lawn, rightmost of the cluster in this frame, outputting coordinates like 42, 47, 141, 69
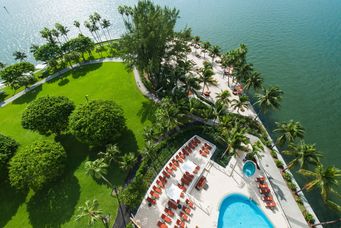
70, 100, 126, 146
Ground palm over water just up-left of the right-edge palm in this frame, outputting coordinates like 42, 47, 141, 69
283, 141, 322, 171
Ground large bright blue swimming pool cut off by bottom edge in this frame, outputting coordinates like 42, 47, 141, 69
218, 194, 274, 228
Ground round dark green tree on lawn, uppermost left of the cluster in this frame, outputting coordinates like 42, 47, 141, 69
21, 96, 75, 135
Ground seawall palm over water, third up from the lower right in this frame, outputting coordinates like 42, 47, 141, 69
274, 120, 304, 146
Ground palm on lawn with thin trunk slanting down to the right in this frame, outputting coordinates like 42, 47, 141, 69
85, 158, 113, 187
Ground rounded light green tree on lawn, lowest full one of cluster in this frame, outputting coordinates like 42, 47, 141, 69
9, 141, 66, 191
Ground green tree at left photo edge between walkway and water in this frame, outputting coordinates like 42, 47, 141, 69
0, 62, 34, 89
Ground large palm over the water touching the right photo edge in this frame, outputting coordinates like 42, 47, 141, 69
296, 163, 341, 204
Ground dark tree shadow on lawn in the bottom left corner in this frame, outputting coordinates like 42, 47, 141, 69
0, 181, 27, 227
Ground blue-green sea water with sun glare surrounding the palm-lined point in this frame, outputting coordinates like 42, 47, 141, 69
0, 0, 341, 223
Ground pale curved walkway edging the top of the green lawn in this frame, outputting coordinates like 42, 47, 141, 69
0, 58, 159, 108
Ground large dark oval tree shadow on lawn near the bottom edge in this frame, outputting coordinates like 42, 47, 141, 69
27, 173, 80, 227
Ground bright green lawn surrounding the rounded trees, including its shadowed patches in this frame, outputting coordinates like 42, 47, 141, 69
0, 63, 152, 227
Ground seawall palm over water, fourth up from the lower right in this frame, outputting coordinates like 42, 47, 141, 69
255, 86, 283, 115
